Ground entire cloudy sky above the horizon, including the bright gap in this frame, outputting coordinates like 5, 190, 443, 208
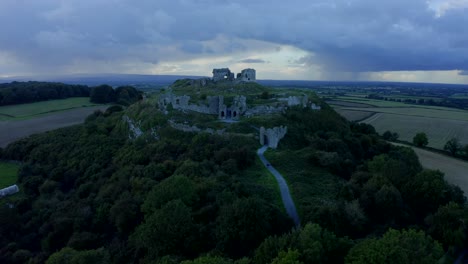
0, 0, 468, 83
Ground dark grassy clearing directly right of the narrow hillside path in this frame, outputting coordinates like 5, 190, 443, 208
265, 150, 344, 219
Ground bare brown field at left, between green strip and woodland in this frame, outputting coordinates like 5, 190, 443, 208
0, 106, 108, 148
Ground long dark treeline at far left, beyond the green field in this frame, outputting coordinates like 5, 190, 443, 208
0, 82, 91, 105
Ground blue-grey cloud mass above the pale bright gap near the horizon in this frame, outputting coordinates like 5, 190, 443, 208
0, 0, 468, 72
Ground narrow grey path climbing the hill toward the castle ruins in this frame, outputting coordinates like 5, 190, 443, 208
257, 146, 301, 227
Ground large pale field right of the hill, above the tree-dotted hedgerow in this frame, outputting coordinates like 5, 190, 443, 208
329, 96, 468, 149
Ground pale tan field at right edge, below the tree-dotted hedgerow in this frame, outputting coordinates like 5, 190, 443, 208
395, 144, 468, 196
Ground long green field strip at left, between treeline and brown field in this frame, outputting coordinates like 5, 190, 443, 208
0, 97, 97, 121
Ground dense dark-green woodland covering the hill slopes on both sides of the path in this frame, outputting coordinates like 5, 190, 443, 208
0, 99, 468, 264
